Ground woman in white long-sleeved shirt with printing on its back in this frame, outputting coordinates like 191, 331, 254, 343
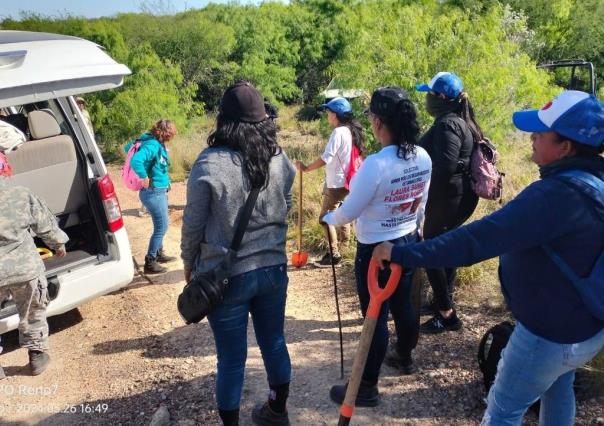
323, 87, 432, 407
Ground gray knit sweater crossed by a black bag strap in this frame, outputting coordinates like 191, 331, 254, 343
180, 147, 296, 275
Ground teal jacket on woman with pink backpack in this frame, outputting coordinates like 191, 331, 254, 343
124, 133, 170, 188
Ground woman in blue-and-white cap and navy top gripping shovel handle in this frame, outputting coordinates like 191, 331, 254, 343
373, 90, 604, 426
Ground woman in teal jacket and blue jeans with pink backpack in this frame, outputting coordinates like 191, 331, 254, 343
124, 120, 177, 274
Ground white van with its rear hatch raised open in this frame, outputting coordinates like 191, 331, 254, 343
0, 31, 134, 334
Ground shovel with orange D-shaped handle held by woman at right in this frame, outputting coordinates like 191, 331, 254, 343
338, 258, 403, 426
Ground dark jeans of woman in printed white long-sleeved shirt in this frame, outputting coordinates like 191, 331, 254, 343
354, 232, 419, 383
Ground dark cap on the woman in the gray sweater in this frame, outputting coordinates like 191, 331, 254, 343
220, 81, 268, 123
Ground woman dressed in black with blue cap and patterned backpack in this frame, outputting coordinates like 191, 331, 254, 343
416, 72, 483, 334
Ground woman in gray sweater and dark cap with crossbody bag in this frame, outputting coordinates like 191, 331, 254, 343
181, 82, 295, 425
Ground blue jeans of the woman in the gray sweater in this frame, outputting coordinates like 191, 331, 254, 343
208, 265, 291, 410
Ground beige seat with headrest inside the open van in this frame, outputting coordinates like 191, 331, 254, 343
8, 110, 87, 227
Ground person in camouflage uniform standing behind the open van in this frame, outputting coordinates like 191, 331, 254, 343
0, 153, 69, 376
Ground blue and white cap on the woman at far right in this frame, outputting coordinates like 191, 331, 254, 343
512, 90, 604, 146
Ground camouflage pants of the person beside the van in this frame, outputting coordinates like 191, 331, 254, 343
0, 275, 49, 351
